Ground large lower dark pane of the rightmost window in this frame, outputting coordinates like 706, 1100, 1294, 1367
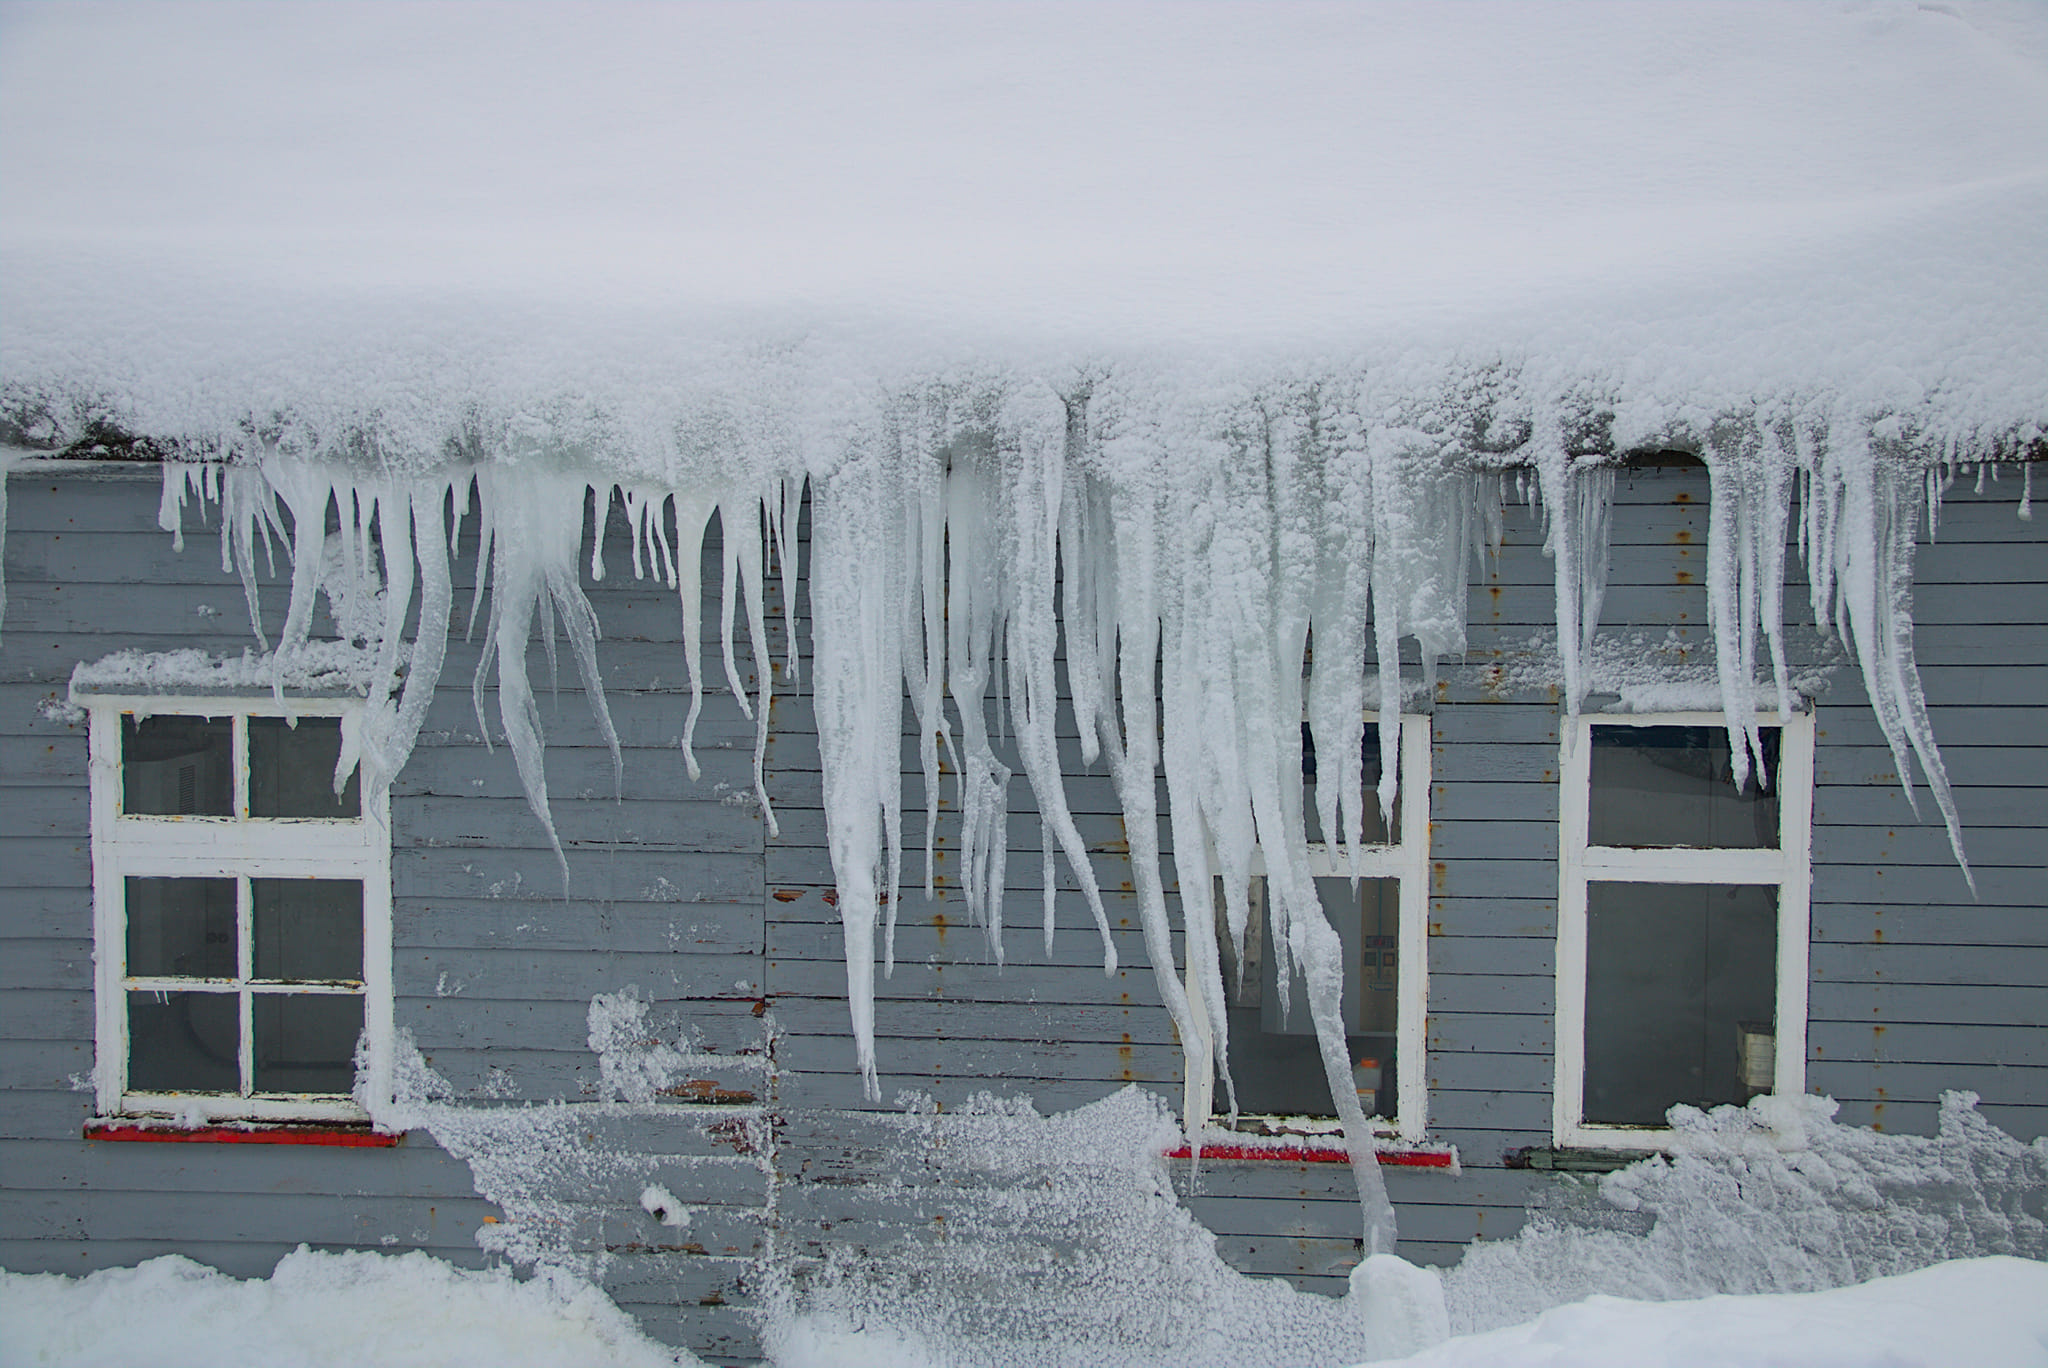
1585, 883, 1778, 1126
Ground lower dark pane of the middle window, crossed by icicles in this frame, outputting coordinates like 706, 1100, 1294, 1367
1217, 879, 1401, 1116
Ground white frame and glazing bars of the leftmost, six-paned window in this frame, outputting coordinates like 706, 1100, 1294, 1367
72, 694, 393, 1122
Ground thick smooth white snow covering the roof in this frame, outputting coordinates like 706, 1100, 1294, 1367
0, 2, 2048, 469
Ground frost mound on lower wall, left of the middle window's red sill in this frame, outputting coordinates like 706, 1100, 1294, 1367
762, 1087, 1444, 1368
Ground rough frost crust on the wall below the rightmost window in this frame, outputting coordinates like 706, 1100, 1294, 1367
1446, 1094, 2048, 1333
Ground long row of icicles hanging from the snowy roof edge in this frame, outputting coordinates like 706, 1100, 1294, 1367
112, 393, 1998, 1249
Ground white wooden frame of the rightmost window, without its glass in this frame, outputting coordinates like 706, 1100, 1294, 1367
1552, 711, 1812, 1149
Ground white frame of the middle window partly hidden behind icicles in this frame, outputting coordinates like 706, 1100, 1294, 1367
1182, 713, 1430, 1153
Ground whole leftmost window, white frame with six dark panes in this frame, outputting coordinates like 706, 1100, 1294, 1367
88, 698, 391, 1120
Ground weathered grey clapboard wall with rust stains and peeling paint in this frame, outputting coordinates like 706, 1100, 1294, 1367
0, 456, 2048, 1358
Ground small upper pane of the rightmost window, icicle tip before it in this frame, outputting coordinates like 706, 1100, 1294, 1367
1587, 727, 1778, 850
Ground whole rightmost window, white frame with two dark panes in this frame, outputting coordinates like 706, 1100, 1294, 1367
1554, 715, 1812, 1147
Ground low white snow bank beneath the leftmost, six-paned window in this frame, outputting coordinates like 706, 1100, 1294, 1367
0, 1245, 702, 1368
